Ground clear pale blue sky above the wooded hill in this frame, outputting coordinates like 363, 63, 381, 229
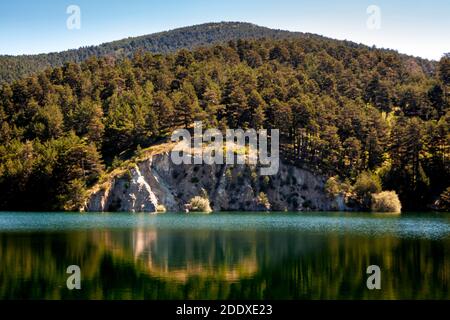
0, 0, 450, 60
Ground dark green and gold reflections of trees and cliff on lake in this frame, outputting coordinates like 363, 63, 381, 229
0, 229, 450, 299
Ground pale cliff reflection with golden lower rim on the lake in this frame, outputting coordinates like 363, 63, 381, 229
93, 228, 324, 283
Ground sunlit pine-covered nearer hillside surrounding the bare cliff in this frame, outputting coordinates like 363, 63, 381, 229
0, 37, 450, 210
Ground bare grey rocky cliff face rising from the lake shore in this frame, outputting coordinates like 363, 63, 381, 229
81, 147, 348, 212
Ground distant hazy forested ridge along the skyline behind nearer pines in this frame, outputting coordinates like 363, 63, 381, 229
0, 22, 434, 83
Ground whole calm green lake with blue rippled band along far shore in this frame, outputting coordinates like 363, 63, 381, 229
0, 212, 450, 299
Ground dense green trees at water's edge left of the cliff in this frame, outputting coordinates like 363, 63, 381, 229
0, 133, 103, 210
